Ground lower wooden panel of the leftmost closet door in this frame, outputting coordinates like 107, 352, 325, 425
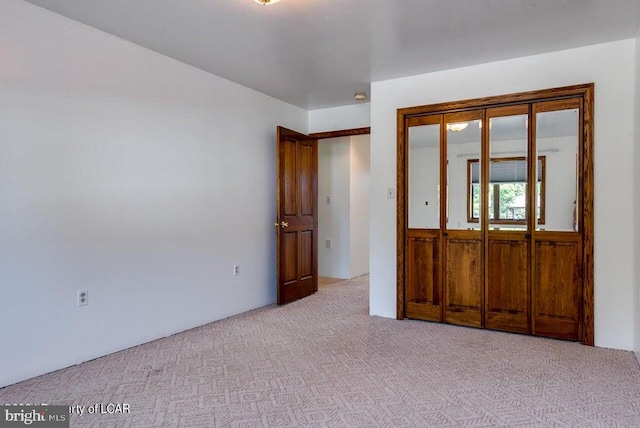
406, 231, 441, 321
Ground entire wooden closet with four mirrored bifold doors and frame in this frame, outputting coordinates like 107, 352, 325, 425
397, 84, 593, 345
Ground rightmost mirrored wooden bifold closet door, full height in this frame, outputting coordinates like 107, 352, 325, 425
532, 99, 584, 340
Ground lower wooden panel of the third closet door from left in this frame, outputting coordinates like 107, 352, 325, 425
486, 239, 529, 333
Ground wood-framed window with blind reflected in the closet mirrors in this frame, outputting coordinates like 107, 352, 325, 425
467, 156, 546, 224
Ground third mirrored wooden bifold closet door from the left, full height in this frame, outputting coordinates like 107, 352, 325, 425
484, 105, 528, 333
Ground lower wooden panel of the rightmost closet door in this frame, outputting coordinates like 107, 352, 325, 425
533, 236, 582, 340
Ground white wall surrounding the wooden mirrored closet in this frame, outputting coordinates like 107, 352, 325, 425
370, 39, 635, 350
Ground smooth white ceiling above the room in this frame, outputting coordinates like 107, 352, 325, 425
23, 0, 640, 109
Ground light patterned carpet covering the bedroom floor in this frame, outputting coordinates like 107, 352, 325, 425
0, 276, 640, 427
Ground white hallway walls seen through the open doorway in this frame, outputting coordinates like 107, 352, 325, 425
318, 135, 370, 278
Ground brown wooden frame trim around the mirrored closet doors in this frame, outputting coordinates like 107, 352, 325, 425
396, 83, 595, 346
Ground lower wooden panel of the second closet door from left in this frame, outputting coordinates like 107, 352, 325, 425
444, 231, 483, 327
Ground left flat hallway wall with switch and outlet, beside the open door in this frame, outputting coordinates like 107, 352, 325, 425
318, 137, 351, 278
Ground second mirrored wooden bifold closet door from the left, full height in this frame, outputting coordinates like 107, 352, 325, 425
442, 110, 484, 327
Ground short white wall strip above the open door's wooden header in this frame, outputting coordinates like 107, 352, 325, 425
309, 103, 371, 133
